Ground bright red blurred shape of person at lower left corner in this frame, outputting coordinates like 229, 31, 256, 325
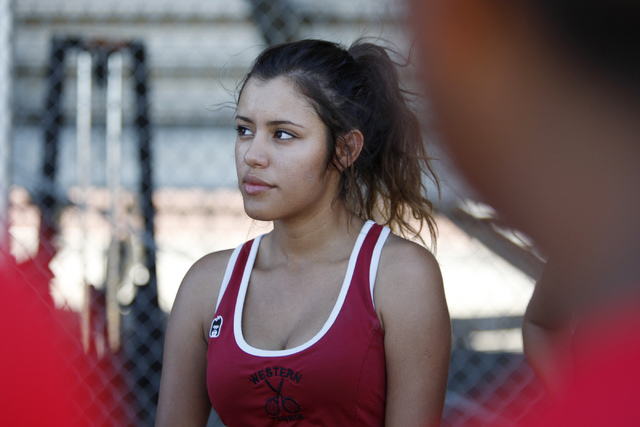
0, 254, 80, 426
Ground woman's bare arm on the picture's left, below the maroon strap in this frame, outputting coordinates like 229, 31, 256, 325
156, 253, 228, 426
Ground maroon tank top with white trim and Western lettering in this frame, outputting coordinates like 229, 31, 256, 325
207, 221, 389, 427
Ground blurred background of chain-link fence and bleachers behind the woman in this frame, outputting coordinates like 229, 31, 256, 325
0, 0, 542, 426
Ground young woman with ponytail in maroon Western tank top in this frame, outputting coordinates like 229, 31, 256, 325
157, 40, 451, 426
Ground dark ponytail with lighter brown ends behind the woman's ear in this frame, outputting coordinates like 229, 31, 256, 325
343, 41, 439, 246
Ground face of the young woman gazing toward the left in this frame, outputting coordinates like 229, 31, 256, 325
235, 77, 339, 221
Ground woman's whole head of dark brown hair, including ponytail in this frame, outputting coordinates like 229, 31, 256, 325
238, 40, 439, 243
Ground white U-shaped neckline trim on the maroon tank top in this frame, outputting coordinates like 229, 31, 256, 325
225, 220, 388, 357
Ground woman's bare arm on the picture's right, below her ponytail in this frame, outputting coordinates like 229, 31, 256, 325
375, 240, 451, 427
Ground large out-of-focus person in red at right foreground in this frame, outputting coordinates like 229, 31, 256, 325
410, 0, 640, 425
